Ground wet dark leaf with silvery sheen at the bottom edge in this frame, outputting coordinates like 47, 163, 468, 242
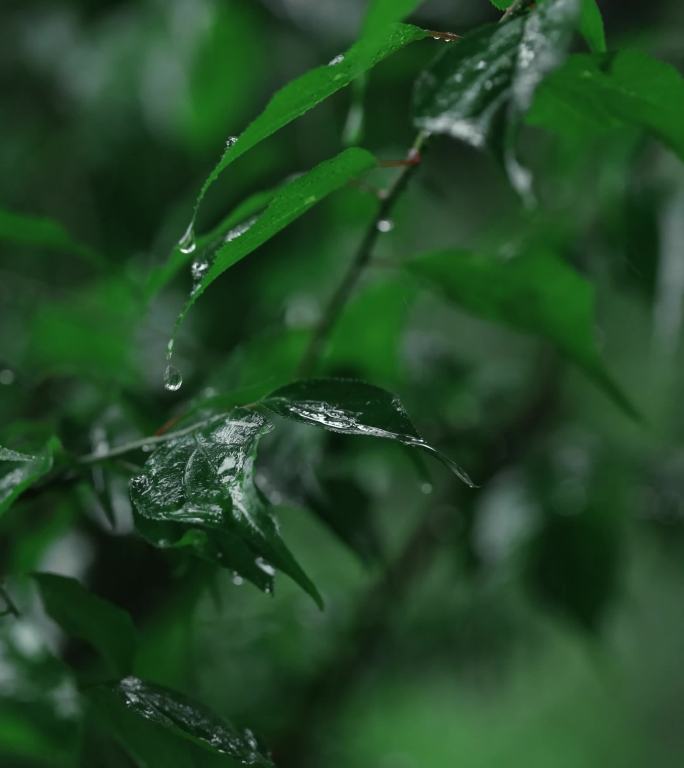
91, 677, 273, 768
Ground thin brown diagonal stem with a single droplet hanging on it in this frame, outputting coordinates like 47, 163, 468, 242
298, 132, 428, 378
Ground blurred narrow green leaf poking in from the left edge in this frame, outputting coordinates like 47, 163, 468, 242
0, 209, 106, 267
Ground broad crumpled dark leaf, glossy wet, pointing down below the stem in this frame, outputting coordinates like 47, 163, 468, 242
130, 409, 322, 605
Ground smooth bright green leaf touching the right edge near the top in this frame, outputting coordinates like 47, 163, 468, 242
527, 51, 684, 160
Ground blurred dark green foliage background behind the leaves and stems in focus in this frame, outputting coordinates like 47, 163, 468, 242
0, 0, 684, 768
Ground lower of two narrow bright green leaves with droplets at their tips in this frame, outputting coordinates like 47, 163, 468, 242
171, 148, 376, 332
